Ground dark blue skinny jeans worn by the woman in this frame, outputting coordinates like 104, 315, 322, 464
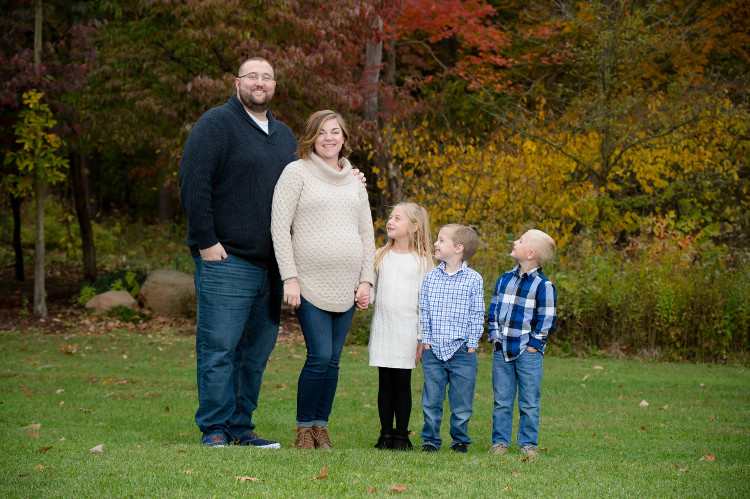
296, 296, 354, 427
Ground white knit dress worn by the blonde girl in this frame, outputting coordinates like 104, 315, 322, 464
368, 251, 426, 369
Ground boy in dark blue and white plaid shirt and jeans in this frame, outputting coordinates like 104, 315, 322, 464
488, 230, 557, 456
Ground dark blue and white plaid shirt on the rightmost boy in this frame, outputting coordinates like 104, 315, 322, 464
488, 265, 557, 362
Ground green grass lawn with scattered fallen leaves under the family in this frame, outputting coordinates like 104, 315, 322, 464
0, 329, 750, 498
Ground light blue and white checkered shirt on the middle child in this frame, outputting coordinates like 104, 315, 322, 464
419, 262, 484, 362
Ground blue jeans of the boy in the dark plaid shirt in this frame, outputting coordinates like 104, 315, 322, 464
492, 349, 543, 448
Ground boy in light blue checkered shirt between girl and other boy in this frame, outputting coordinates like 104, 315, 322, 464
419, 224, 484, 452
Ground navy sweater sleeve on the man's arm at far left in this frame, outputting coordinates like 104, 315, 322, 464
180, 116, 227, 249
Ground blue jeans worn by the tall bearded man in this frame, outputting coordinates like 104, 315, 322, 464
195, 255, 283, 440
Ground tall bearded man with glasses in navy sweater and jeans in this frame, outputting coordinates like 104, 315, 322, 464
180, 57, 297, 449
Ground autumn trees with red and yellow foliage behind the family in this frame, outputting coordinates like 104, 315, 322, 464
0, 0, 750, 358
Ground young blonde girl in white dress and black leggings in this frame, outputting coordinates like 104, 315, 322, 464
369, 202, 433, 450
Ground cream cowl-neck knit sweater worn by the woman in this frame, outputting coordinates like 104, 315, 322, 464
271, 153, 375, 312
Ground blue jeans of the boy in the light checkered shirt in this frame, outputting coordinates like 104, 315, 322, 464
421, 345, 478, 449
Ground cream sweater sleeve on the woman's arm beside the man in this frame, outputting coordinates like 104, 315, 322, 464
271, 163, 304, 280
